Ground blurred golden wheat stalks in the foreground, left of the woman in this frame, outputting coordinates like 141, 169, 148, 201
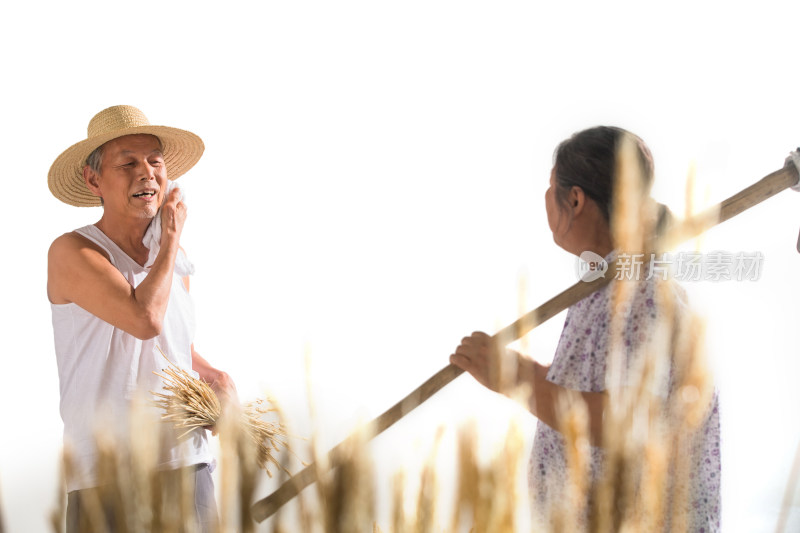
52, 400, 524, 533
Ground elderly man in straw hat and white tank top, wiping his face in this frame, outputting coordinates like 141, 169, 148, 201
47, 106, 236, 531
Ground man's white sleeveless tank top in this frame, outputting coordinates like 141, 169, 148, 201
50, 225, 213, 491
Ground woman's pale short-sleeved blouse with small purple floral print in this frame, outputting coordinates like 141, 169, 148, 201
528, 278, 721, 533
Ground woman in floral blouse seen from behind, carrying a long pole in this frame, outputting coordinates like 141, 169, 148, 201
450, 127, 720, 532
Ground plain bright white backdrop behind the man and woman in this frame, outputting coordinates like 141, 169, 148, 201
0, 1, 800, 532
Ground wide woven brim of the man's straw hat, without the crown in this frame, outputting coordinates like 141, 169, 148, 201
47, 125, 205, 207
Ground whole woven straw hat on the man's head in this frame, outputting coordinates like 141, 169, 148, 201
47, 105, 205, 207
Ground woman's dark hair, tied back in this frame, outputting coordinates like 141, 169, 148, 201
553, 126, 653, 221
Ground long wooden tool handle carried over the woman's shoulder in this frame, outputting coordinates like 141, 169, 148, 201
251, 164, 800, 522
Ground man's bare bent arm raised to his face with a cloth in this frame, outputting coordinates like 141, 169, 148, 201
47, 188, 186, 339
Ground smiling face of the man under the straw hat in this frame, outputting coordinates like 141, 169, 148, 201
87, 135, 167, 218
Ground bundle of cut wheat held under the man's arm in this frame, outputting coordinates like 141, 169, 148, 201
153, 362, 291, 476
